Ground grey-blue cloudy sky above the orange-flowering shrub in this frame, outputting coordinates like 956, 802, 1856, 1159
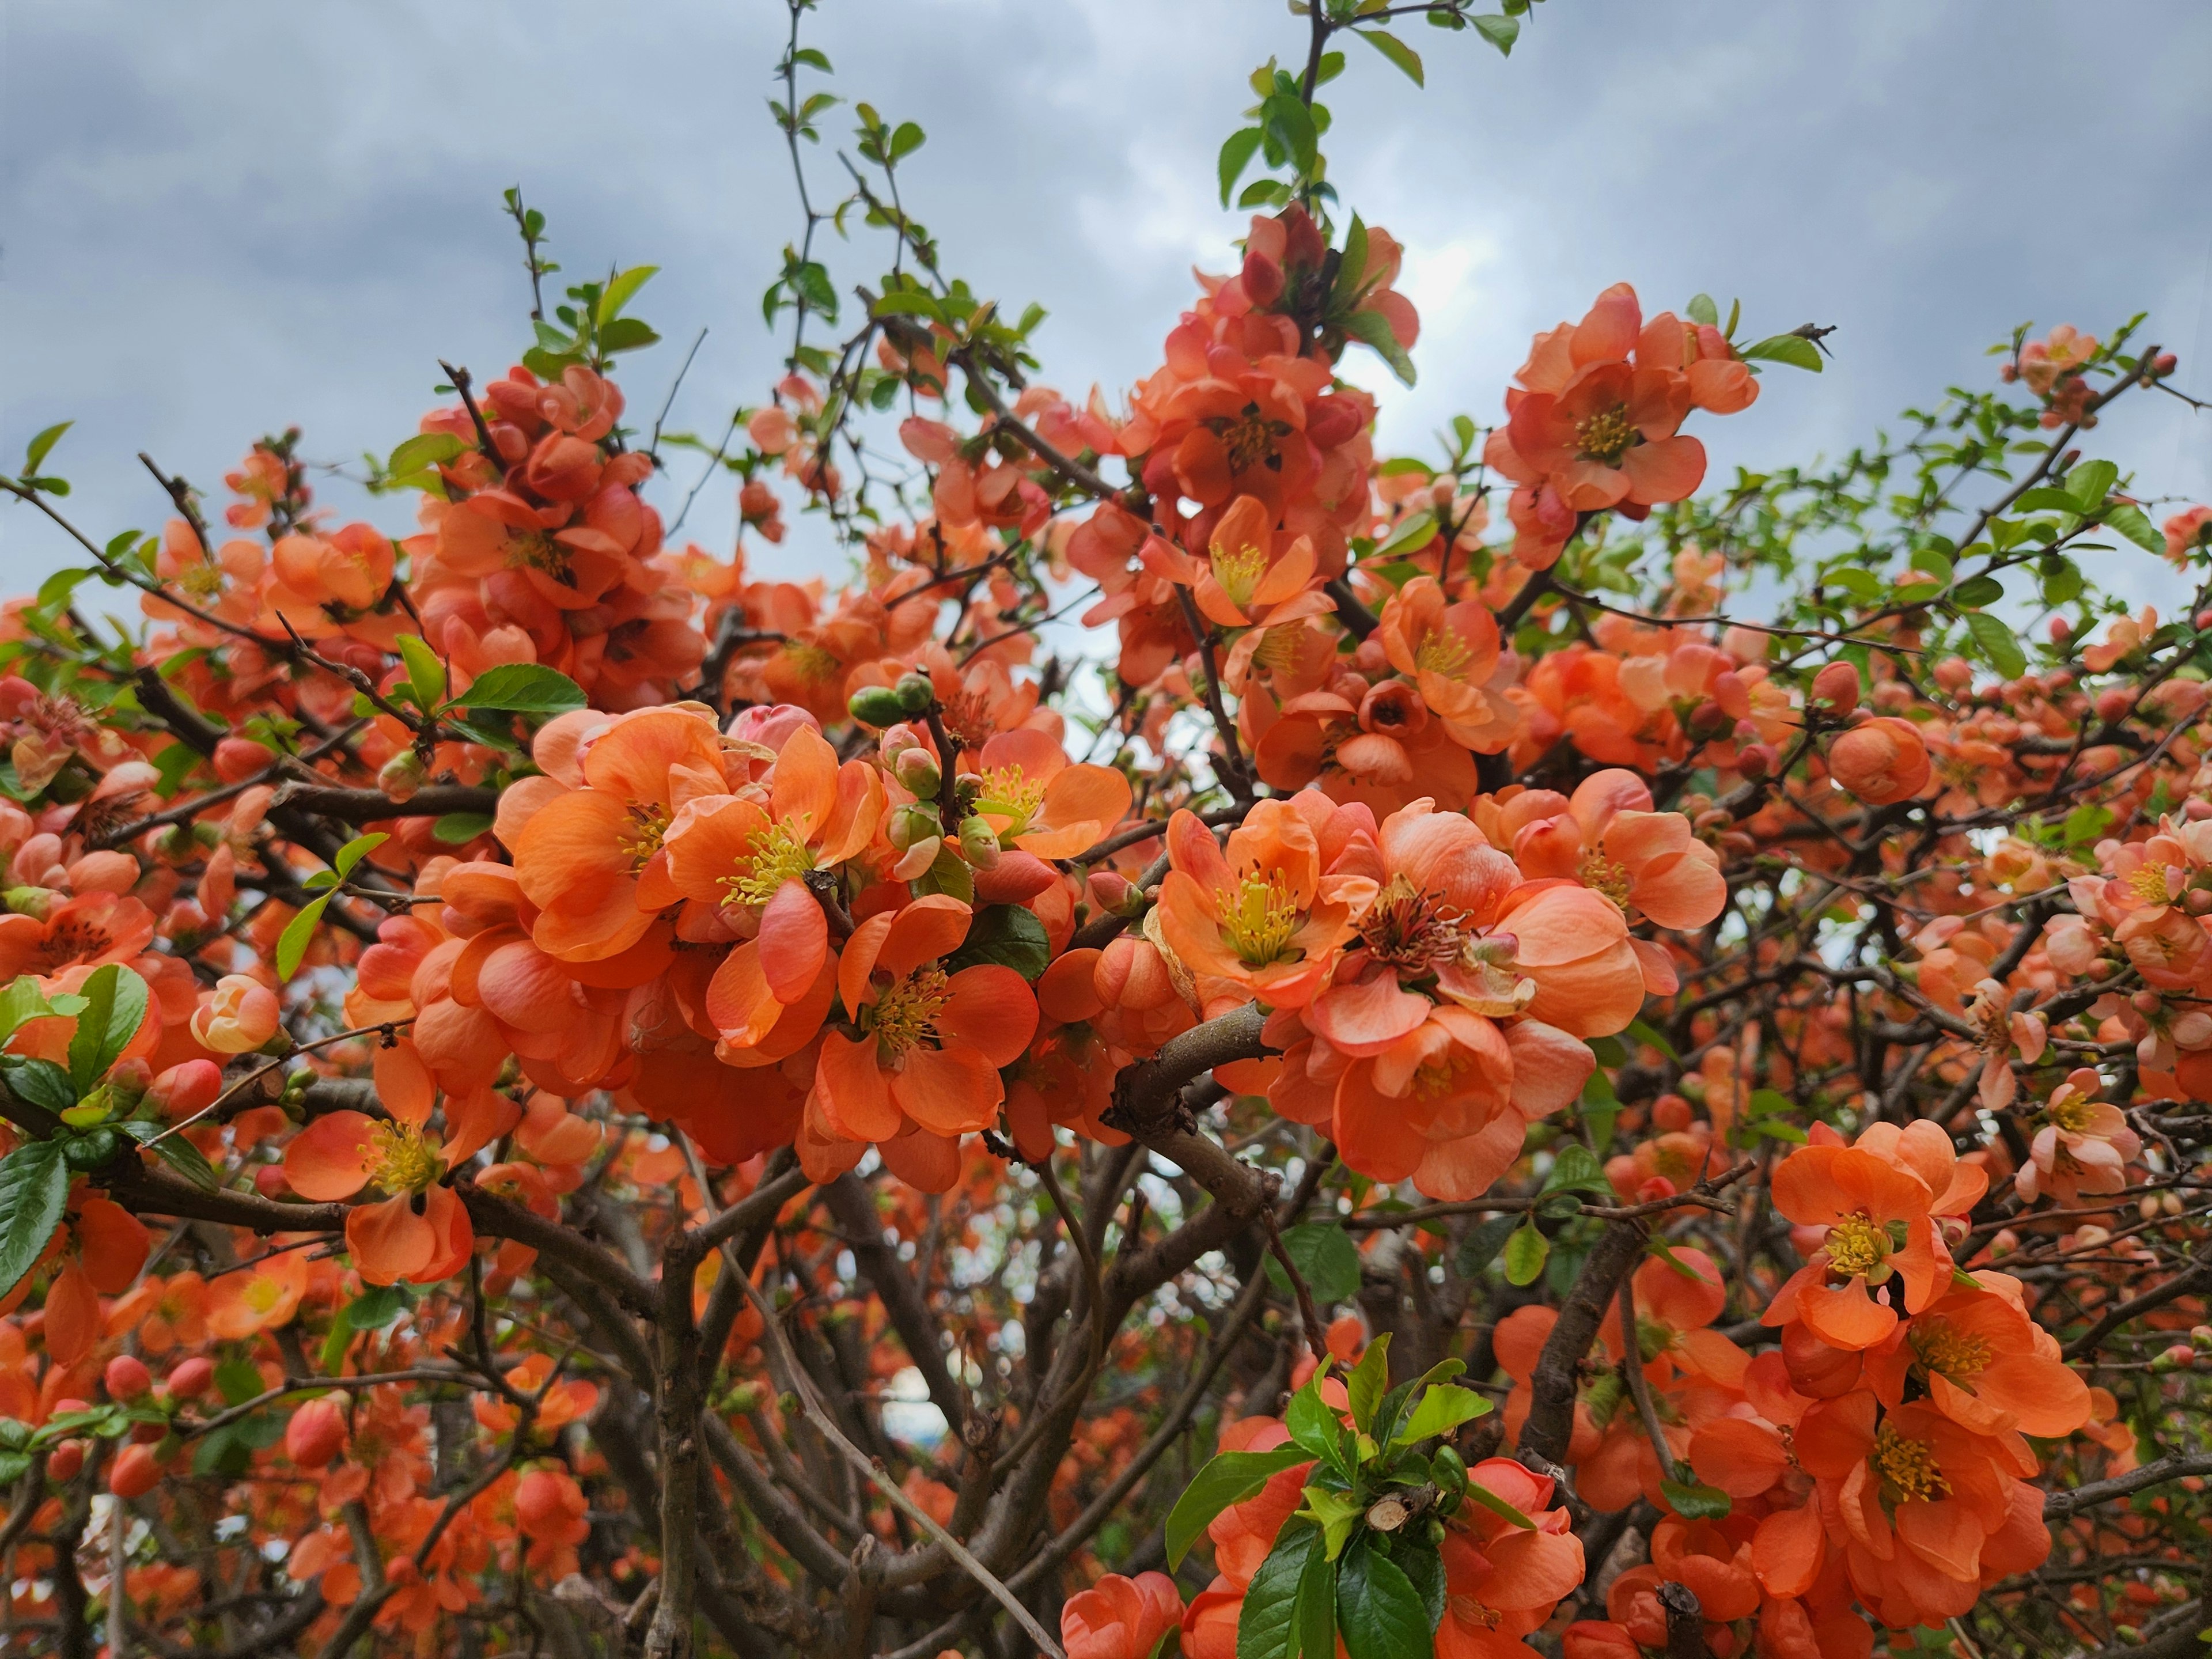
0, 0, 2212, 610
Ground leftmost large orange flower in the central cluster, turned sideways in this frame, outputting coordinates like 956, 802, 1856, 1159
516, 708, 726, 962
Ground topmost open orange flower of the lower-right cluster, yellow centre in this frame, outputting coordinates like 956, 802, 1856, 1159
1761, 1146, 1951, 1349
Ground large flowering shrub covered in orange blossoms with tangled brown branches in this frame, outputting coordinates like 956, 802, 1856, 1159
0, 0, 2212, 1659
